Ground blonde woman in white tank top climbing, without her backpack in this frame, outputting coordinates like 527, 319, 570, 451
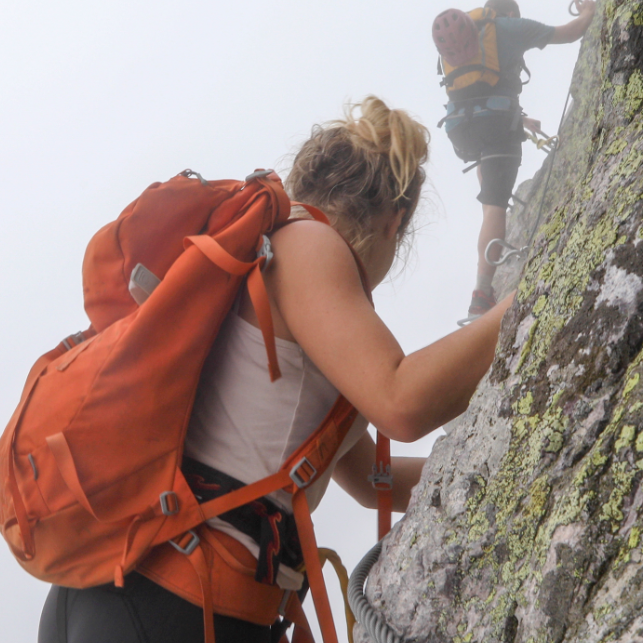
39, 97, 511, 643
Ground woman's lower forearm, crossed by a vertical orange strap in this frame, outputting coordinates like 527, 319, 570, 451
333, 433, 426, 513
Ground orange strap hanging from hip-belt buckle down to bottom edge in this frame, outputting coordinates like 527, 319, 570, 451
292, 489, 338, 643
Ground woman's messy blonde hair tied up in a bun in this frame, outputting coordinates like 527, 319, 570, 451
286, 96, 430, 256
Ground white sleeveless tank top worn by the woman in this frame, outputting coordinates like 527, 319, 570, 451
185, 312, 368, 589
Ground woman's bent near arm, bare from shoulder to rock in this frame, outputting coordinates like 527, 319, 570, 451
266, 221, 511, 442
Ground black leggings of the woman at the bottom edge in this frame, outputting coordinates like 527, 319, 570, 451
38, 573, 271, 643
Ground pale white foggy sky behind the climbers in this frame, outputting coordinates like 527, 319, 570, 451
0, 0, 578, 643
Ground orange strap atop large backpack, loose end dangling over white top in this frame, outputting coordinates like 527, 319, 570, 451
184, 235, 281, 382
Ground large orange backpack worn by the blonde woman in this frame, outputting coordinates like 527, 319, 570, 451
0, 170, 357, 643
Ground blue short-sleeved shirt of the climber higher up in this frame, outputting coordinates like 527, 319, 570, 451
494, 17, 555, 96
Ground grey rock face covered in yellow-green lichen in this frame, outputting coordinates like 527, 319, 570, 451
356, 0, 643, 643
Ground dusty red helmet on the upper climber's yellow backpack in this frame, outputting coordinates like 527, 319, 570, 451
432, 9, 480, 67
